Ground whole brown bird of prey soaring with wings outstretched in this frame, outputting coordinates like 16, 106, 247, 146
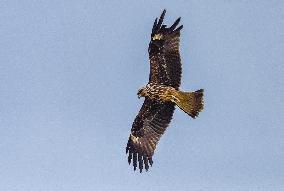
126, 10, 203, 172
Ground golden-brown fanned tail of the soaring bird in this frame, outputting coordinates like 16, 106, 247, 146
174, 89, 204, 118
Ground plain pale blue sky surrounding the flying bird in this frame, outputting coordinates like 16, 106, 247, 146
0, 0, 284, 191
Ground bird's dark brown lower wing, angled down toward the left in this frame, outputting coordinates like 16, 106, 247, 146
126, 98, 175, 172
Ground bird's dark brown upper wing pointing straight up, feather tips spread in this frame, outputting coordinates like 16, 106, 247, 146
148, 10, 183, 89
